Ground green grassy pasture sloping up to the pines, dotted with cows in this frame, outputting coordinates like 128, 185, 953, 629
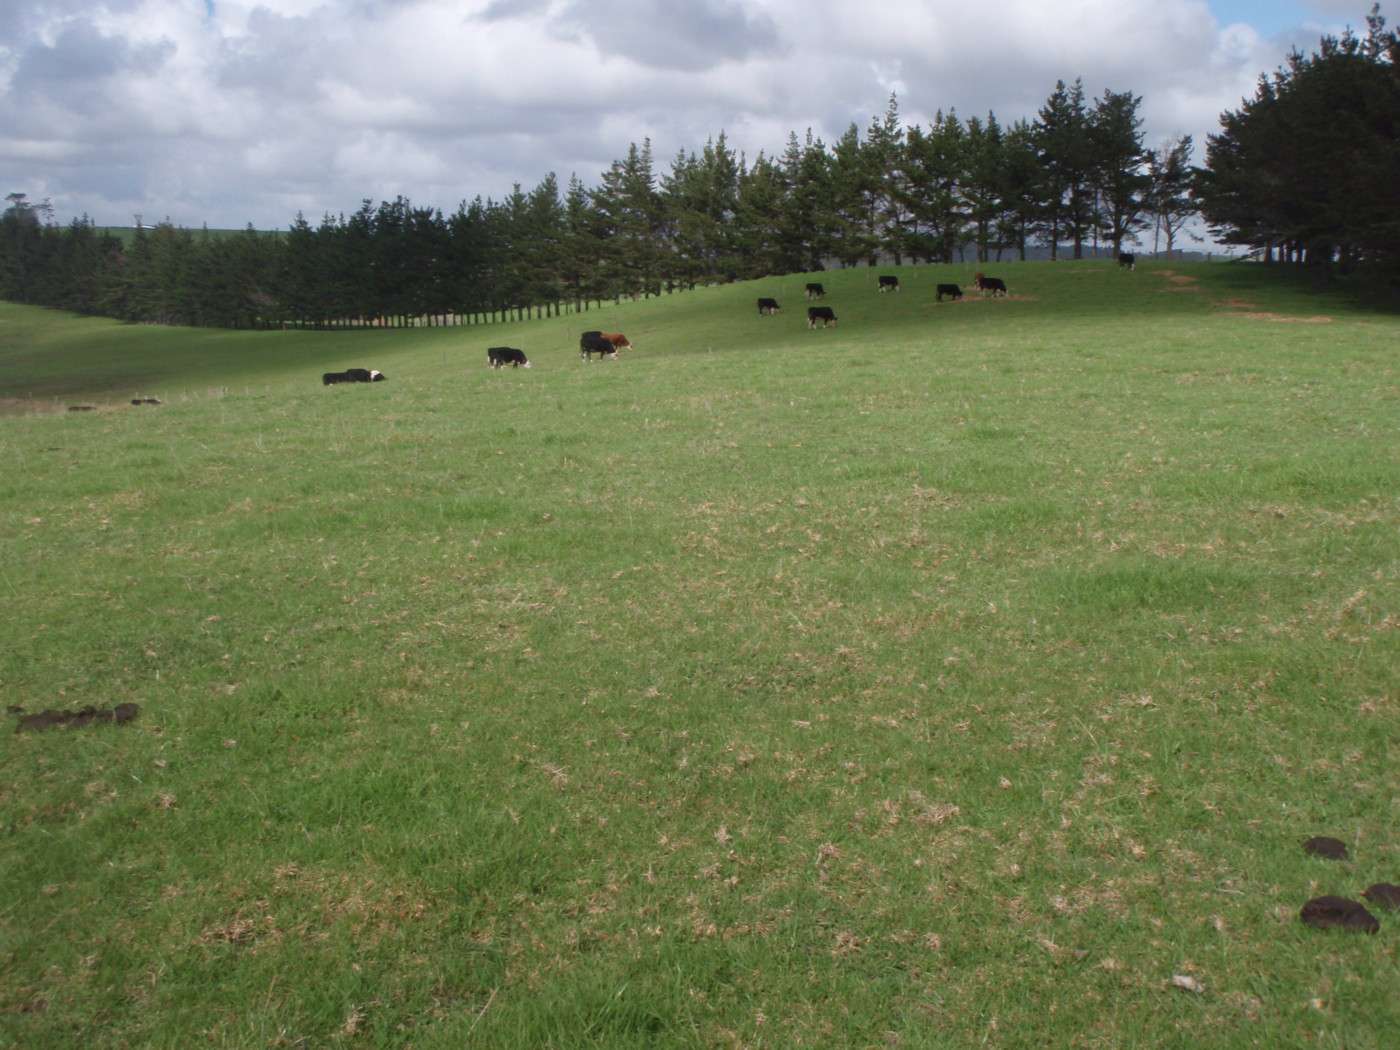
0, 263, 1400, 1049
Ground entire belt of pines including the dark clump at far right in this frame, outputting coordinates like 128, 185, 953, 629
0, 8, 1400, 328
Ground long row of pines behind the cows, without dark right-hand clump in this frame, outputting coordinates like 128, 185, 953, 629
0, 81, 1194, 328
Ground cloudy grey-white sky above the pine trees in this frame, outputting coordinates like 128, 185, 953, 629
0, 0, 1386, 228
